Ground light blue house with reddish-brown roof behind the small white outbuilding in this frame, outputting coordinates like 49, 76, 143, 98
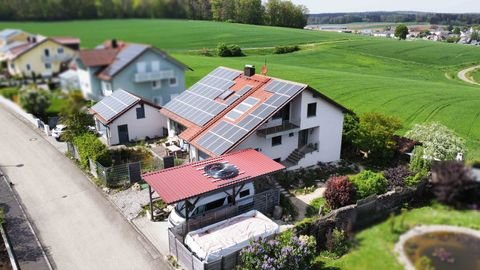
76, 40, 190, 106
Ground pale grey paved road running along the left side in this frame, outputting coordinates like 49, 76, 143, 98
0, 106, 167, 270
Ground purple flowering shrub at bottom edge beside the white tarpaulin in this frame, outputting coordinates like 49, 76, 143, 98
240, 232, 316, 270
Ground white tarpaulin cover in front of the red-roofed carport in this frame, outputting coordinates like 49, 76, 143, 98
185, 210, 279, 262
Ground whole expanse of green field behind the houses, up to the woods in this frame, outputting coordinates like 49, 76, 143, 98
0, 20, 480, 159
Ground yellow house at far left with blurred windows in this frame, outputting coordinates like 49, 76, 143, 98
7, 36, 80, 77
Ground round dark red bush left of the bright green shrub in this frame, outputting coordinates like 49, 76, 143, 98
325, 176, 356, 209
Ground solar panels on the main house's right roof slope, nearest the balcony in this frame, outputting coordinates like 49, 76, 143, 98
197, 80, 306, 156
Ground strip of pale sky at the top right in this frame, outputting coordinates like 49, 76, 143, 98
292, 0, 480, 13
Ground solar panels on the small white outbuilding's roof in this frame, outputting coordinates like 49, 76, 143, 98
92, 89, 140, 122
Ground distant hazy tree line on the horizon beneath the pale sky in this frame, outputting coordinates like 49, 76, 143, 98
308, 12, 480, 25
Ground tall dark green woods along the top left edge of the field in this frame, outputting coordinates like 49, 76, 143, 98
0, 0, 308, 28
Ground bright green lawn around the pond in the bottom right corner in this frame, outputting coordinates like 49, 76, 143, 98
317, 204, 480, 270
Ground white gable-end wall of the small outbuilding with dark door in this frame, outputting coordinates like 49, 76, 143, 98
104, 104, 167, 145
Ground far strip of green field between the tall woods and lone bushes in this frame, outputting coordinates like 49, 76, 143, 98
0, 19, 352, 51
